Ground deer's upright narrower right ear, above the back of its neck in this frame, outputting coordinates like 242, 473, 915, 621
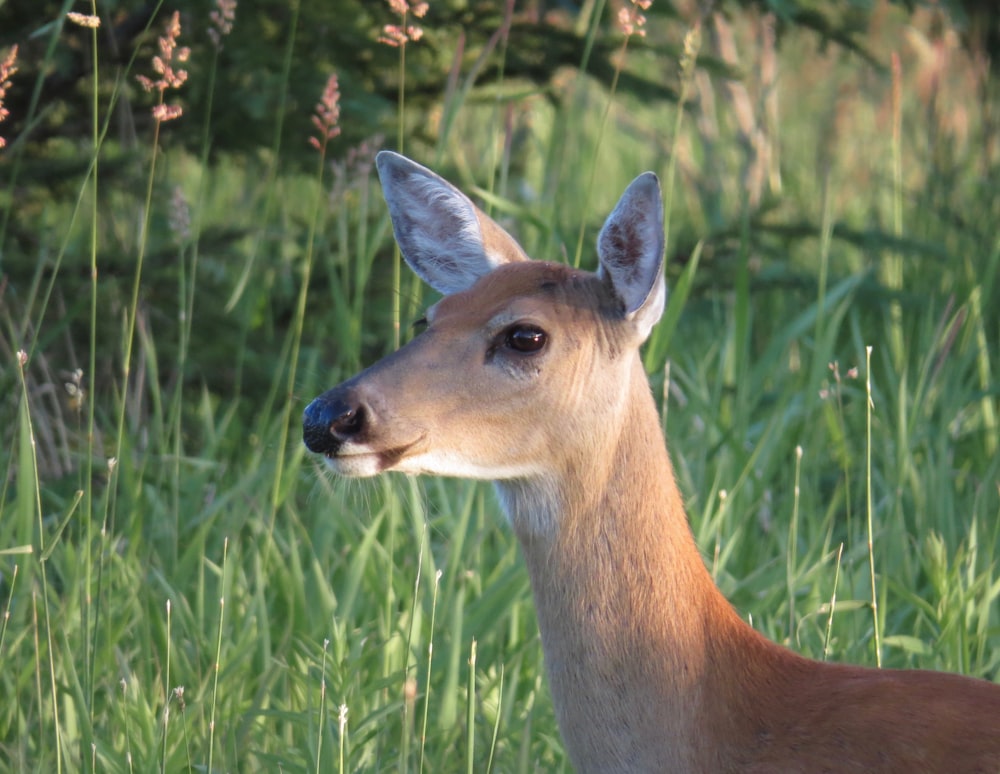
597, 172, 667, 340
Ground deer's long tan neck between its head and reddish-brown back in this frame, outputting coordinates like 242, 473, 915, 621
498, 358, 755, 771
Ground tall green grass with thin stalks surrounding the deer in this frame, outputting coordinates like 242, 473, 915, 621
0, 4, 1000, 772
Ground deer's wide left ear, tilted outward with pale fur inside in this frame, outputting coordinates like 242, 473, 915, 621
375, 151, 528, 295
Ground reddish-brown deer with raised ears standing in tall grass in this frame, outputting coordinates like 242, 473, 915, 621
303, 151, 1000, 774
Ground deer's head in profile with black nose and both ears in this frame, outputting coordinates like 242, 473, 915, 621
303, 151, 666, 516
